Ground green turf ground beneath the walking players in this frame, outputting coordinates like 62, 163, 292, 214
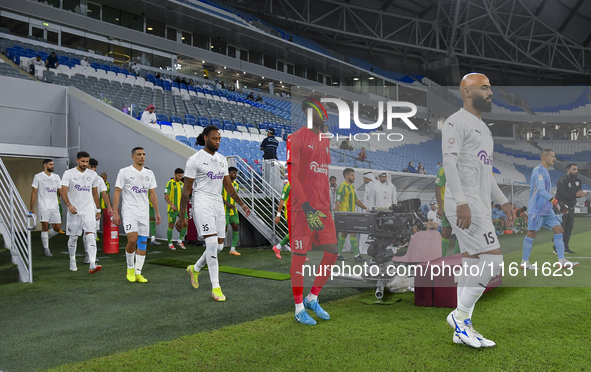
0, 217, 591, 371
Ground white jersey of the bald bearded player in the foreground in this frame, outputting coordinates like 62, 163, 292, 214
441, 108, 494, 216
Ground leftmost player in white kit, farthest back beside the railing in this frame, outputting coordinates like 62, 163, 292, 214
29, 159, 62, 257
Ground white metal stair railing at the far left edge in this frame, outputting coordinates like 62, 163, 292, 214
0, 159, 37, 283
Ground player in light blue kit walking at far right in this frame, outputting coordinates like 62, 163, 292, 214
520, 149, 579, 270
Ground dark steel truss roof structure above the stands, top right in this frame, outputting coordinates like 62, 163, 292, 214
226, 0, 591, 76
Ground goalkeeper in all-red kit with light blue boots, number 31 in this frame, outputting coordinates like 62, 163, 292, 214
287, 97, 338, 325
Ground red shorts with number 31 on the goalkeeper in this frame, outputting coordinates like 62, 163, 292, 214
287, 209, 337, 253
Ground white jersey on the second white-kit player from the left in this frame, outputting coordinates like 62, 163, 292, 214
61, 168, 98, 214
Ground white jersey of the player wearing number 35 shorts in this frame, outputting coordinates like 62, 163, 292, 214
185, 150, 228, 205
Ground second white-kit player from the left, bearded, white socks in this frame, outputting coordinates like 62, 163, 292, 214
60, 151, 102, 274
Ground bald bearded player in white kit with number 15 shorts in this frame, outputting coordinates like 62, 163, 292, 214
441, 73, 515, 348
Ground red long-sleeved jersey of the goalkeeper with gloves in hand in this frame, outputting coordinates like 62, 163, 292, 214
287, 127, 330, 212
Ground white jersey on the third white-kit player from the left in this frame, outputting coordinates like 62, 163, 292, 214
115, 165, 157, 216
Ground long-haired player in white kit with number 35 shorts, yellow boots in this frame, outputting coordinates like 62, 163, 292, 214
176, 125, 250, 301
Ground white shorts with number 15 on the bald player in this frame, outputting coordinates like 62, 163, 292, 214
446, 212, 501, 255
